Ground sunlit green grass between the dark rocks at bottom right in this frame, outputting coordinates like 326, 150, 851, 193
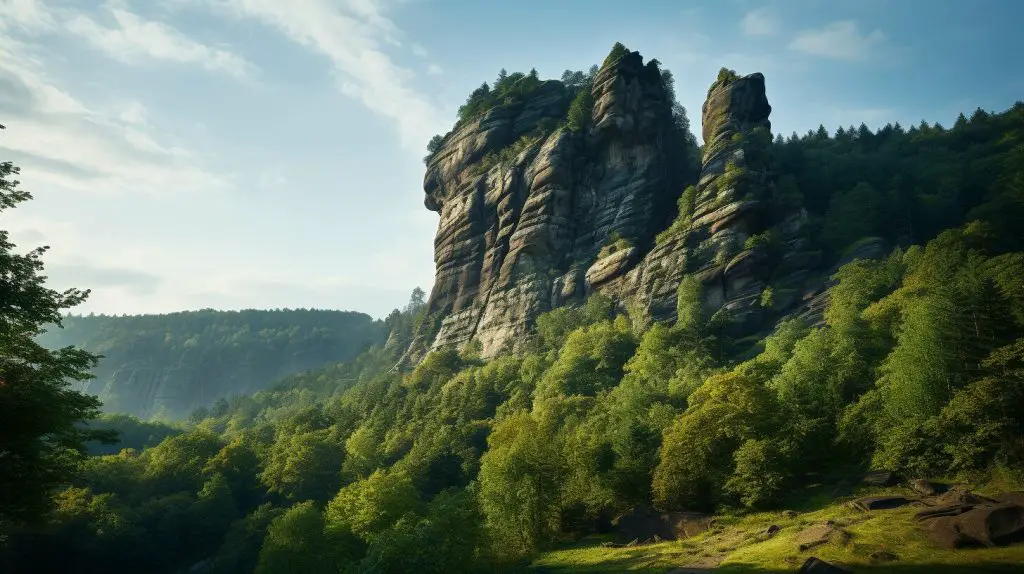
531, 478, 1024, 574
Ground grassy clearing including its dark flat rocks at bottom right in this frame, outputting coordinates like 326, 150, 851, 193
532, 474, 1024, 574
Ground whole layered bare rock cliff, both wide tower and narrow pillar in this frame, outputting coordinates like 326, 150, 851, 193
420, 52, 880, 356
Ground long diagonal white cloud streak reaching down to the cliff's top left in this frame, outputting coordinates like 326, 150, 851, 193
198, 0, 446, 152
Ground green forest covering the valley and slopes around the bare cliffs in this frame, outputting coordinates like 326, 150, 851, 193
0, 43, 1024, 574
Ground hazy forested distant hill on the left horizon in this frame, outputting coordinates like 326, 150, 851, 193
39, 309, 386, 420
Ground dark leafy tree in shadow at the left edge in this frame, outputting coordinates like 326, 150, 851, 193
0, 126, 113, 535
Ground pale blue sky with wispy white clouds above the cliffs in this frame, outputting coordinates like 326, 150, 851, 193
0, 0, 1024, 316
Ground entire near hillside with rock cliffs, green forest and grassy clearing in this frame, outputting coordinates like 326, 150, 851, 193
6, 44, 1024, 574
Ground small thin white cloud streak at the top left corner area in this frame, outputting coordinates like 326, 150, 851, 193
65, 0, 253, 77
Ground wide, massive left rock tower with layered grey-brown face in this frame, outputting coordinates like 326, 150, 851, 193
415, 52, 674, 356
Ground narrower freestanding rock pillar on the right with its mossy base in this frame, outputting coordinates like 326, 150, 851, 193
609, 74, 820, 336
